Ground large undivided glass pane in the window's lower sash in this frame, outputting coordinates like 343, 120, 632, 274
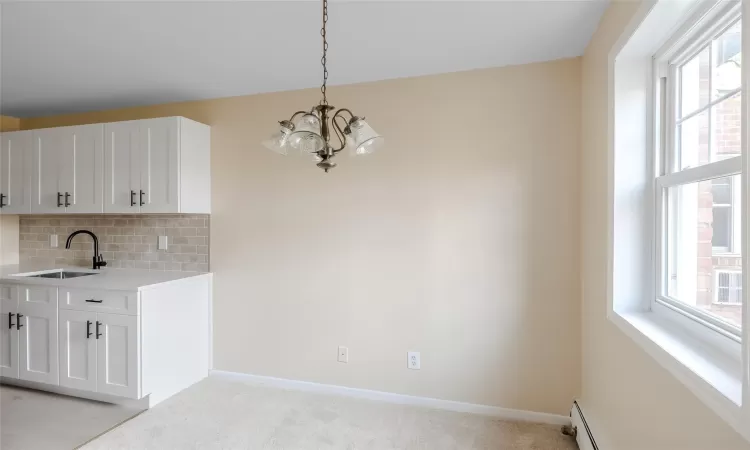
666, 175, 742, 327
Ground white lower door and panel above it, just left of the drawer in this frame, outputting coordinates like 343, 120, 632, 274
16, 286, 59, 384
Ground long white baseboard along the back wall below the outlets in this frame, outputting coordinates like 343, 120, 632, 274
211, 370, 570, 425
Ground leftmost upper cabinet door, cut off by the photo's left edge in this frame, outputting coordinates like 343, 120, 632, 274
0, 131, 33, 214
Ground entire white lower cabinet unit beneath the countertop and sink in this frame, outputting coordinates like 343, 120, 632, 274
0, 274, 211, 408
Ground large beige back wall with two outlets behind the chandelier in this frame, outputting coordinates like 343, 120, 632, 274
22, 59, 581, 414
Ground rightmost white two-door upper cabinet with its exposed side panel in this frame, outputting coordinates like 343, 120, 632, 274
104, 117, 211, 213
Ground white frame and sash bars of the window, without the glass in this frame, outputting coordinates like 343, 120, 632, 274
651, 3, 747, 342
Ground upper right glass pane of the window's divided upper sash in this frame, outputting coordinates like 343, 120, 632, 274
711, 21, 742, 99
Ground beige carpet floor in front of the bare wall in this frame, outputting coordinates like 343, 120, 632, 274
83, 378, 577, 450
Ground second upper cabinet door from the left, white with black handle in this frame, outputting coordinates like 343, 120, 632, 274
31, 128, 65, 214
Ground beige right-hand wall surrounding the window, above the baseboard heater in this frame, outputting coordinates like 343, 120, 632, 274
581, 2, 750, 450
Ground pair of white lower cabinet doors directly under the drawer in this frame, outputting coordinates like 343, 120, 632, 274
60, 309, 140, 398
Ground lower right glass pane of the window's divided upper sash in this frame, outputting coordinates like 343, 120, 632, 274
707, 93, 742, 162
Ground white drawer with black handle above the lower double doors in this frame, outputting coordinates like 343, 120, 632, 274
60, 288, 139, 316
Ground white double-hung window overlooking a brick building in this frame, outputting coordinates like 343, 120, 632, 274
655, 8, 743, 338
